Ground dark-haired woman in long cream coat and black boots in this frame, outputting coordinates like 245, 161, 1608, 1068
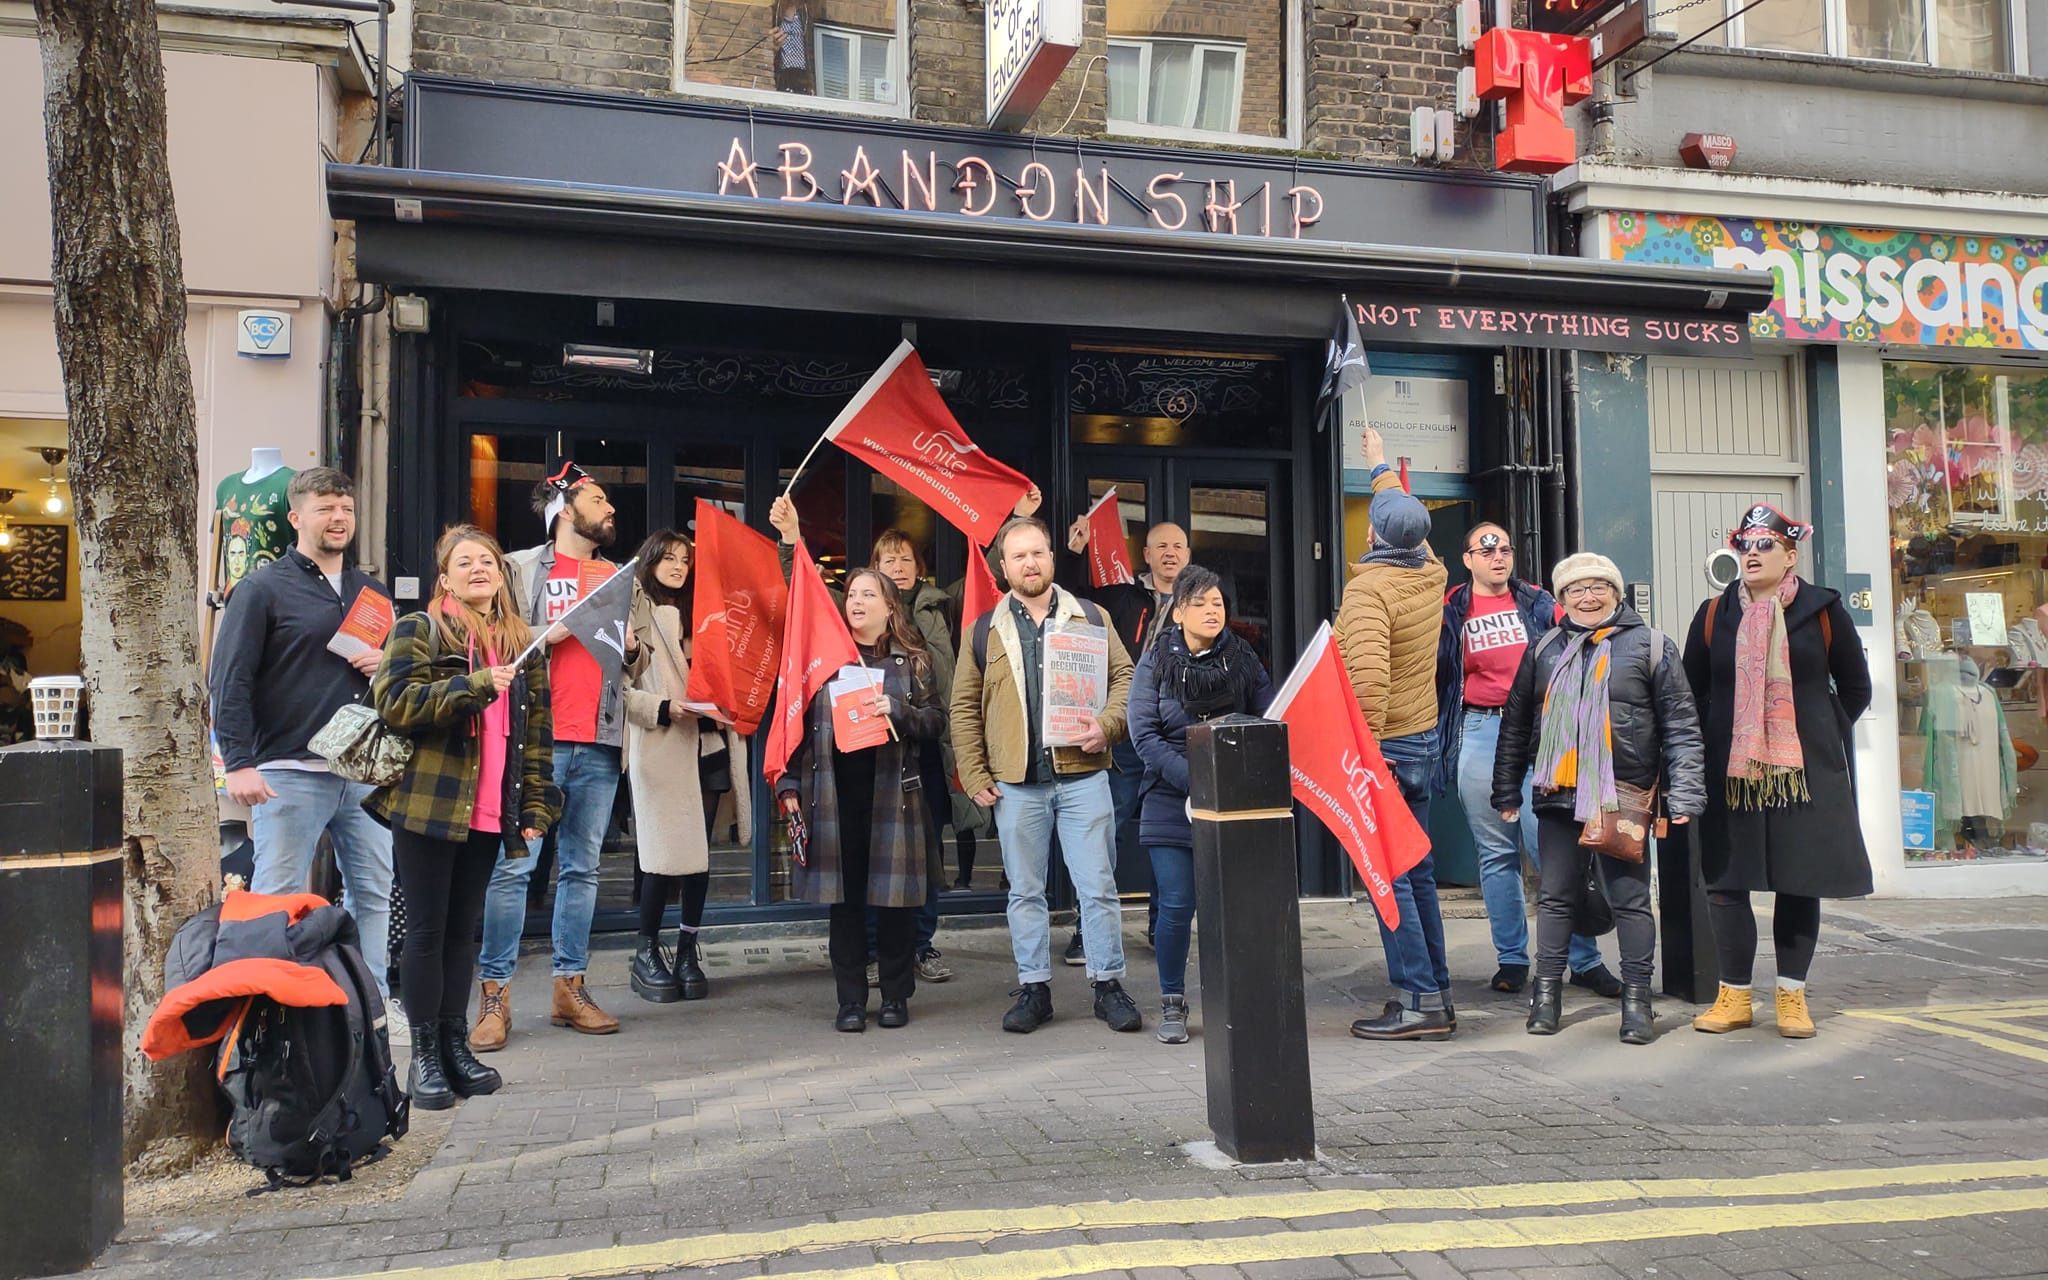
625, 528, 752, 1004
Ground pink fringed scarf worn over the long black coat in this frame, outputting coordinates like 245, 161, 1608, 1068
1726, 573, 1808, 809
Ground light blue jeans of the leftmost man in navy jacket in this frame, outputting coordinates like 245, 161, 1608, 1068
250, 768, 391, 999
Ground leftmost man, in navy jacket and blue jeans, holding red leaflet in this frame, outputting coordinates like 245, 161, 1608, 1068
209, 467, 391, 995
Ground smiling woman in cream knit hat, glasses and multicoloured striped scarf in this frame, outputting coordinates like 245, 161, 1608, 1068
1493, 551, 1706, 1044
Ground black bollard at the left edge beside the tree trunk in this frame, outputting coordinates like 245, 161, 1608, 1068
0, 741, 123, 1280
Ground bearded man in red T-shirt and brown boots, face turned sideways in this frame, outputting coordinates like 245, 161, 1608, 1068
469, 463, 637, 1053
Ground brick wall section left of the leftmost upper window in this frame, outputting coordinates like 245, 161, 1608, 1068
412, 0, 674, 92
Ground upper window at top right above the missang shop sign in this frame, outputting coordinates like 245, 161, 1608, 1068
1653, 0, 2023, 72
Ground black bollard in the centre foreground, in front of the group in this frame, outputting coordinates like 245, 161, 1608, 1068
1188, 715, 1315, 1163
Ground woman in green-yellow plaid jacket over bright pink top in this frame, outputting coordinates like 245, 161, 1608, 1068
362, 524, 561, 1110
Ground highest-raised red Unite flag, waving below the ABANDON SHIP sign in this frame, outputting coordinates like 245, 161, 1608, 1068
825, 342, 1030, 547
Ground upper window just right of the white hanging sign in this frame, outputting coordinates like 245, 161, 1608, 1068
1108, 0, 1300, 139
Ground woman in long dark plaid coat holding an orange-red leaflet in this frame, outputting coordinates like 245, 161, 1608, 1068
776, 569, 946, 1030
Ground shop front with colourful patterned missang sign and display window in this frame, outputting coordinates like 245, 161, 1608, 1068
1564, 175, 2048, 895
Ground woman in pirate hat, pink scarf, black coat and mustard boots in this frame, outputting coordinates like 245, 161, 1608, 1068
1686, 504, 1870, 1040
